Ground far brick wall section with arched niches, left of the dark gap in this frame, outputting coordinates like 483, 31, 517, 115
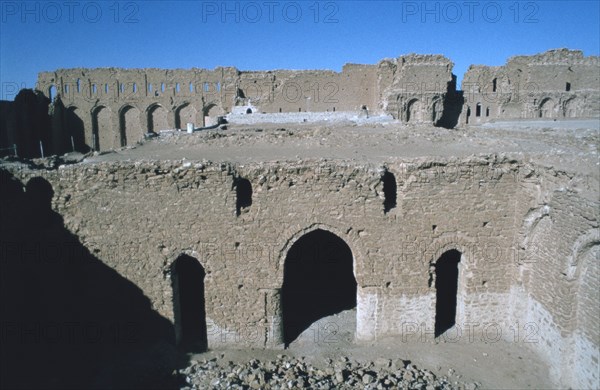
38, 54, 454, 151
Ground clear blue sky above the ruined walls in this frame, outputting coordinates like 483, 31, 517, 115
0, 0, 600, 100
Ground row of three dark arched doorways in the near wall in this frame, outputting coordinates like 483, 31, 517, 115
171, 227, 462, 351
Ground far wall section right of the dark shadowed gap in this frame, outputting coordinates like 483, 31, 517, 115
461, 49, 600, 123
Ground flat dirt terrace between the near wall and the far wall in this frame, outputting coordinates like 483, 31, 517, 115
87, 119, 600, 173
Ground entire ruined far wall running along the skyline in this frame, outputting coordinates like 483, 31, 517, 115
0, 49, 600, 157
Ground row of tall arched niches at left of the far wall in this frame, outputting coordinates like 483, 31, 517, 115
65, 103, 220, 152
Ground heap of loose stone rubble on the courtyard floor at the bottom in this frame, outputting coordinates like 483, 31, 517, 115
179, 355, 480, 390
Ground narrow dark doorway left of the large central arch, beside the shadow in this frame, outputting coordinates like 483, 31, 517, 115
174, 255, 208, 352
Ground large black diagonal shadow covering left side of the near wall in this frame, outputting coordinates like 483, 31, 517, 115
0, 170, 186, 389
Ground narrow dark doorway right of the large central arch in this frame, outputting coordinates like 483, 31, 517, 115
435, 249, 461, 337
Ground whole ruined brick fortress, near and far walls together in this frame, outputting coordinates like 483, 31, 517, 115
0, 50, 600, 388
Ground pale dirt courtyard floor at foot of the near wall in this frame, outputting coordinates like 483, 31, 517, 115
191, 310, 558, 389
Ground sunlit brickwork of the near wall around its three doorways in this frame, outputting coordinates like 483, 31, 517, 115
3, 156, 600, 387
